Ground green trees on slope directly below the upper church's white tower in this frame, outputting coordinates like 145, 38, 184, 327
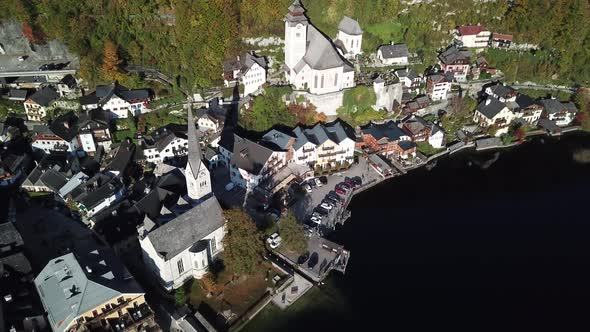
239, 87, 297, 131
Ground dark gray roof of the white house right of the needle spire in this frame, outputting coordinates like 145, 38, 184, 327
231, 135, 273, 175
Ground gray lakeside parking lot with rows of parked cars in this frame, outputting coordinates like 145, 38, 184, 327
292, 158, 381, 228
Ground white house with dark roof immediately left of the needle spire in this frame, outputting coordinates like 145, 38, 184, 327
142, 125, 188, 163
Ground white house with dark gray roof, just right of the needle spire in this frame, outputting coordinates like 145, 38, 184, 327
229, 135, 286, 191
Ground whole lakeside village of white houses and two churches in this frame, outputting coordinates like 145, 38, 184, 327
0, 0, 580, 332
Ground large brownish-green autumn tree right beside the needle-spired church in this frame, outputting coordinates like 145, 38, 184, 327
223, 208, 264, 274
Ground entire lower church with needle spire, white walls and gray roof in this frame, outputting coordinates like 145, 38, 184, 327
138, 104, 225, 291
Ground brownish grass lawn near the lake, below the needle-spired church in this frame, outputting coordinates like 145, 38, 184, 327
189, 262, 283, 317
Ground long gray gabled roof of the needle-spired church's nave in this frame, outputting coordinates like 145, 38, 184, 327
147, 196, 225, 260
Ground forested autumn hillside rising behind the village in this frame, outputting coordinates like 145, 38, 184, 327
0, 0, 590, 86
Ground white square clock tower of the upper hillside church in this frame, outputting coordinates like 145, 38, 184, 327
284, 0, 309, 70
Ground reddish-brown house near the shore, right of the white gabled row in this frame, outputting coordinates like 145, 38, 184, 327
360, 121, 411, 157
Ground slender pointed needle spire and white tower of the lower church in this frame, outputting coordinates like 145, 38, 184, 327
184, 103, 211, 201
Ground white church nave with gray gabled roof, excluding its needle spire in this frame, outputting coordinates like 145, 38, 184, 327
138, 196, 225, 291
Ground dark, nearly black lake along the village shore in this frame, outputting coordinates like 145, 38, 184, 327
244, 134, 590, 331
